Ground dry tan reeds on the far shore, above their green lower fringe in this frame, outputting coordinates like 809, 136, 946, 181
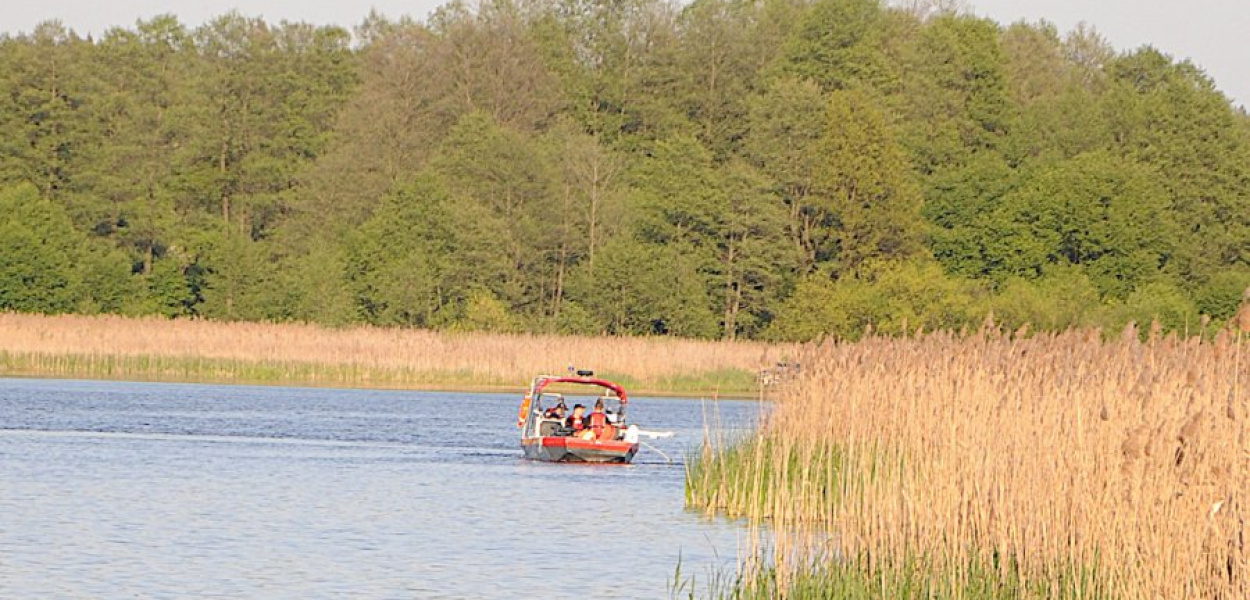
0, 313, 795, 385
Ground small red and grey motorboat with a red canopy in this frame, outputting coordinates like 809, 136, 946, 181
516, 371, 639, 464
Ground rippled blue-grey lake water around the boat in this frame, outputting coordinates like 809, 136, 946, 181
0, 379, 759, 600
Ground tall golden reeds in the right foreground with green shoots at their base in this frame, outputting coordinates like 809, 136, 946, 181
686, 329, 1250, 600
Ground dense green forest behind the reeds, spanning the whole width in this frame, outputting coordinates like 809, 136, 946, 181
0, 0, 1250, 340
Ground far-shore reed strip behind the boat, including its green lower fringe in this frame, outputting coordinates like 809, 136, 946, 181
0, 313, 796, 396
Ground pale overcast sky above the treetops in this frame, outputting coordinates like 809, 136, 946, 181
0, 0, 1250, 105
